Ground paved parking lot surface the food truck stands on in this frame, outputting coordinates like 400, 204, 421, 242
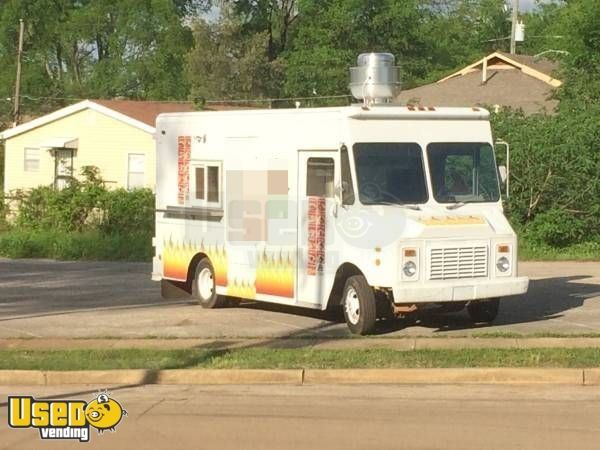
0, 259, 600, 338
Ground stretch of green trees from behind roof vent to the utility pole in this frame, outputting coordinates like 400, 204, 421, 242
285, 0, 510, 96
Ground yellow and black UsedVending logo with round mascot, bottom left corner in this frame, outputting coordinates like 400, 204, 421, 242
8, 392, 127, 442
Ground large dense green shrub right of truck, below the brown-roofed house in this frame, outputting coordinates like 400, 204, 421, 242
492, 106, 600, 246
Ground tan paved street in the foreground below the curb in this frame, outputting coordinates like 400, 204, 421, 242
0, 385, 600, 450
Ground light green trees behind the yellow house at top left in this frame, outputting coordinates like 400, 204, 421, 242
0, 0, 212, 113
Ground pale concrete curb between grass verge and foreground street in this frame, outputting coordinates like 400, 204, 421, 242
0, 368, 600, 386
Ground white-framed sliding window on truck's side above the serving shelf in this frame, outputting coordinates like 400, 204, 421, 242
190, 161, 221, 207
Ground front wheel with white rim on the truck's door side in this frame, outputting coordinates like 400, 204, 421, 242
342, 275, 377, 335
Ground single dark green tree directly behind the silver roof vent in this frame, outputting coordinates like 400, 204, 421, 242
285, 0, 430, 96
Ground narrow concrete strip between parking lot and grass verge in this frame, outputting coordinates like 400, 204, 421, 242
0, 337, 600, 350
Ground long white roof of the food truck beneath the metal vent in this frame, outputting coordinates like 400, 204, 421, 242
157, 104, 490, 120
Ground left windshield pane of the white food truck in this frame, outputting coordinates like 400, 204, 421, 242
353, 142, 427, 205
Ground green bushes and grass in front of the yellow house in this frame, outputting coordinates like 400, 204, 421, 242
0, 166, 154, 261
